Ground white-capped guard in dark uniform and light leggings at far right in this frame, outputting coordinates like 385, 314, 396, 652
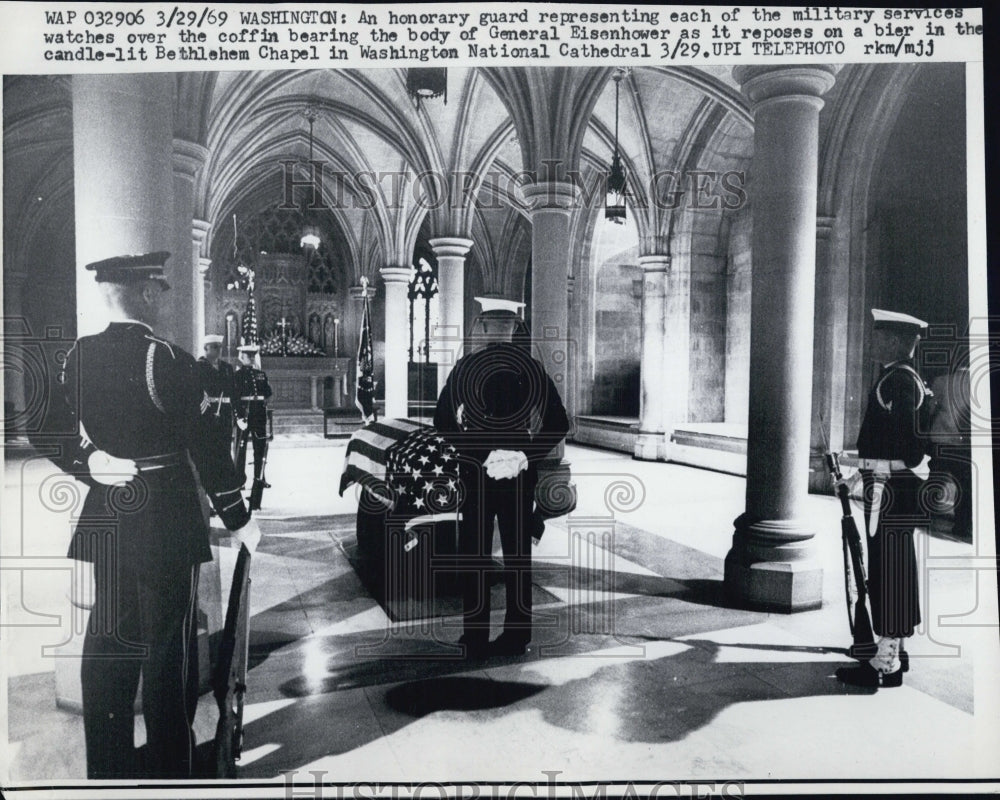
837, 308, 934, 686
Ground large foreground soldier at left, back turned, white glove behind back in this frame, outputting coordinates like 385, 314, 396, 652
30, 252, 260, 778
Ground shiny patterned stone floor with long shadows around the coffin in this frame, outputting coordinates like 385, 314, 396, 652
2, 441, 1000, 783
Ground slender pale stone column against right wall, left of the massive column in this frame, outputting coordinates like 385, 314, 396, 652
635, 255, 670, 461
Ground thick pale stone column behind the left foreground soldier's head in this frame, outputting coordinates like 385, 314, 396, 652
73, 73, 175, 336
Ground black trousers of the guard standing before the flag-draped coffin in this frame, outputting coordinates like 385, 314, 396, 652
458, 465, 538, 641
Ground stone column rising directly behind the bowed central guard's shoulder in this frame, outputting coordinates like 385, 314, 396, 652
524, 181, 577, 404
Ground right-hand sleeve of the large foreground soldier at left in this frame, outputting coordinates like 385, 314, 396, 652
157, 346, 250, 531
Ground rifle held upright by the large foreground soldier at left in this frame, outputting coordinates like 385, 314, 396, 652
212, 544, 250, 778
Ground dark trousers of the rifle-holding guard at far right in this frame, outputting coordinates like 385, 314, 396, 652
862, 470, 927, 638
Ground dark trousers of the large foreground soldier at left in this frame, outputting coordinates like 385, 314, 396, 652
80, 564, 199, 779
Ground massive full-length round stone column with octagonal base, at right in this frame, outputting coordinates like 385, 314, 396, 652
725, 65, 836, 612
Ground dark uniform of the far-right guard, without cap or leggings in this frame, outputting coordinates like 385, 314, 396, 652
858, 361, 931, 638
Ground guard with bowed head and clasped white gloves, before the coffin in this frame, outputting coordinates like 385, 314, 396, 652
434, 298, 569, 658
